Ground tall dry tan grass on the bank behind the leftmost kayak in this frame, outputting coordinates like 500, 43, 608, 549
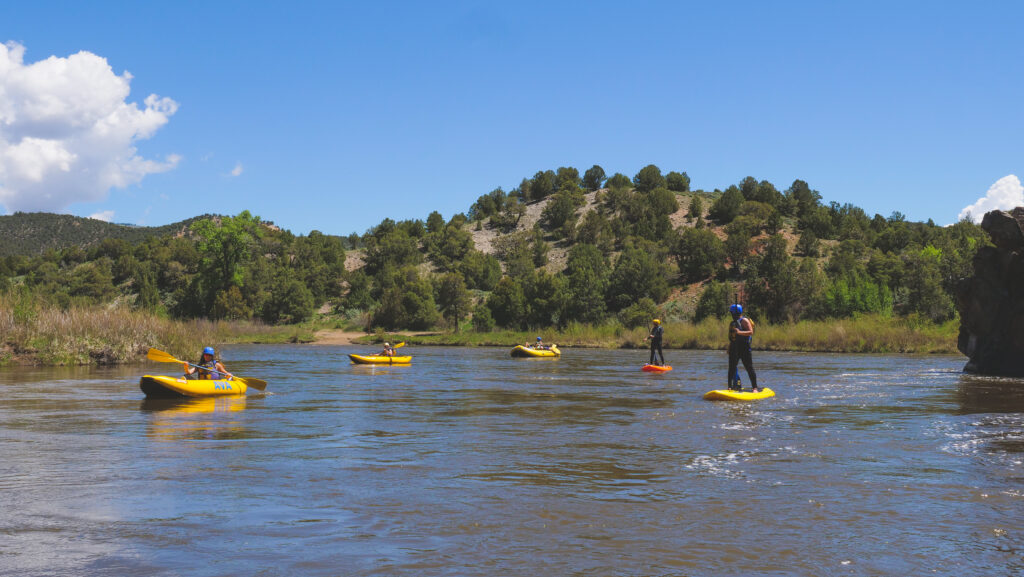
0, 294, 312, 365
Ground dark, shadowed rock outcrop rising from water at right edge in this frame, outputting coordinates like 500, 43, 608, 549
956, 207, 1024, 377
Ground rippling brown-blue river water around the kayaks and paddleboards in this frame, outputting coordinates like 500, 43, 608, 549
0, 345, 1024, 577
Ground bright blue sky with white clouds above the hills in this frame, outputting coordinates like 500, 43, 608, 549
0, 1, 1024, 235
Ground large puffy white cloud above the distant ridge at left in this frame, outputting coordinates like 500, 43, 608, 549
0, 42, 181, 214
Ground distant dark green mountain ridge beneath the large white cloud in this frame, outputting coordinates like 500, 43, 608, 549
0, 212, 214, 257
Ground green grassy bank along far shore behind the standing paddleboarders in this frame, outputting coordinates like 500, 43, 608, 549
367, 316, 959, 354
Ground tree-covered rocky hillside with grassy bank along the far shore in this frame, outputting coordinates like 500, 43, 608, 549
0, 165, 989, 363
